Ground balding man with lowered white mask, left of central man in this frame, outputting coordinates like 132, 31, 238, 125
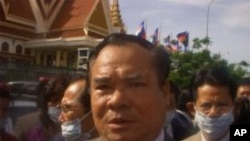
59, 76, 99, 141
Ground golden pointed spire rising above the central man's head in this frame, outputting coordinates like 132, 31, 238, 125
111, 0, 125, 32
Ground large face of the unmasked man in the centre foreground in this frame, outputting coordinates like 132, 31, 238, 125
90, 44, 168, 141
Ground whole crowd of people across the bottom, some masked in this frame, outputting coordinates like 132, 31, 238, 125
0, 33, 250, 141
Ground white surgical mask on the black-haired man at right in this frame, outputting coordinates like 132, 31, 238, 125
195, 110, 233, 138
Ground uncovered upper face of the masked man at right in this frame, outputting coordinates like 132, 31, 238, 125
195, 84, 233, 118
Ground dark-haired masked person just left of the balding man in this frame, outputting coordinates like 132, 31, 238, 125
27, 74, 70, 141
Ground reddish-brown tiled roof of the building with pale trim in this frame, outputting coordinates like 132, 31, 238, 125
0, 0, 106, 39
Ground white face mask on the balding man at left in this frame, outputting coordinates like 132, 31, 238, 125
61, 112, 91, 141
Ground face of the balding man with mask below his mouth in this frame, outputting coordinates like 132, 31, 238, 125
59, 81, 86, 122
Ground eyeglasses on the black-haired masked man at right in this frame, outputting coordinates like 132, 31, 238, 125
197, 103, 232, 114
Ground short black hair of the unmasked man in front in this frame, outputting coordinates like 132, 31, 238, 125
88, 33, 170, 85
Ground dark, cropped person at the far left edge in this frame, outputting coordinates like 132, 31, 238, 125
0, 83, 17, 141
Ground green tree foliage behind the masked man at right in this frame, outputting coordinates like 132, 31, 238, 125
169, 38, 249, 88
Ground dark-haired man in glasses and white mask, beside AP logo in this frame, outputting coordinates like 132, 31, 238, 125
184, 67, 236, 141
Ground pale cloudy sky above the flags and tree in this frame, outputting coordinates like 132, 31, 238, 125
116, 0, 250, 63
